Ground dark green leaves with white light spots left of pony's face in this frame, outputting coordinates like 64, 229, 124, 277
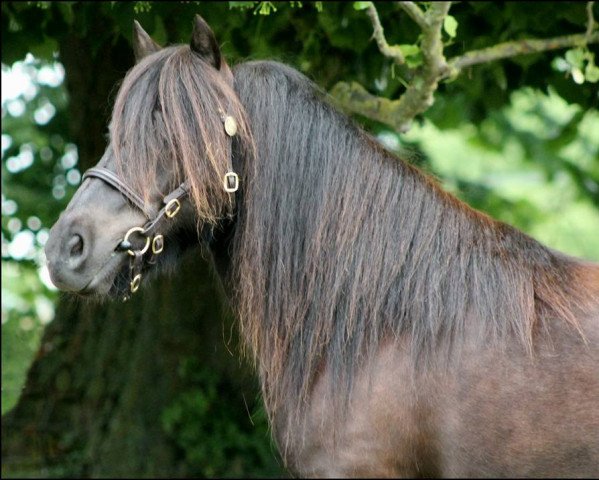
2, 61, 74, 236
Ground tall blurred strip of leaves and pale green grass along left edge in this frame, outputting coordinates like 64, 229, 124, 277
2, 56, 71, 413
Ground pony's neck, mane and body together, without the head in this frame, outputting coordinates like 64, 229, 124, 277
232, 62, 599, 477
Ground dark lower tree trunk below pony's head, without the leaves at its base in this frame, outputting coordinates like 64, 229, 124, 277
2, 250, 255, 478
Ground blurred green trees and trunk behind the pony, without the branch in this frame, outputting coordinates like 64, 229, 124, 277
2, 2, 599, 478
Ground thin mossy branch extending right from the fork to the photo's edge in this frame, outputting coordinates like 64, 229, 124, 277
448, 32, 599, 74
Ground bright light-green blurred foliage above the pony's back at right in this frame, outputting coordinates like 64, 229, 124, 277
402, 89, 599, 260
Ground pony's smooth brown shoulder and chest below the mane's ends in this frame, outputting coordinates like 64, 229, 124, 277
279, 312, 599, 478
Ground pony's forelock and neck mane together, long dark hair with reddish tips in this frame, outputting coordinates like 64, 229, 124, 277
111, 46, 585, 434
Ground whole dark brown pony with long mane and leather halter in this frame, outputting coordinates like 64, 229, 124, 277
46, 17, 599, 477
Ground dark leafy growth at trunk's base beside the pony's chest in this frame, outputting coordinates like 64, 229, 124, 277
162, 357, 283, 478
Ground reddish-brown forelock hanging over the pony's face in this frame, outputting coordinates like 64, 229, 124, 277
110, 46, 253, 224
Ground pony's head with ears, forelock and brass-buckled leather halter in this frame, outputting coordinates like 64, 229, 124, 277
46, 16, 252, 296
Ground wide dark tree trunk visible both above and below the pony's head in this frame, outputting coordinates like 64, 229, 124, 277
2, 7, 280, 478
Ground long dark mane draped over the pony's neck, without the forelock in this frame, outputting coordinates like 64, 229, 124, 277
227, 62, 584, 420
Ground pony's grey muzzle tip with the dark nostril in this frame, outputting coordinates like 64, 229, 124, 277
45, 218, 91, 291
